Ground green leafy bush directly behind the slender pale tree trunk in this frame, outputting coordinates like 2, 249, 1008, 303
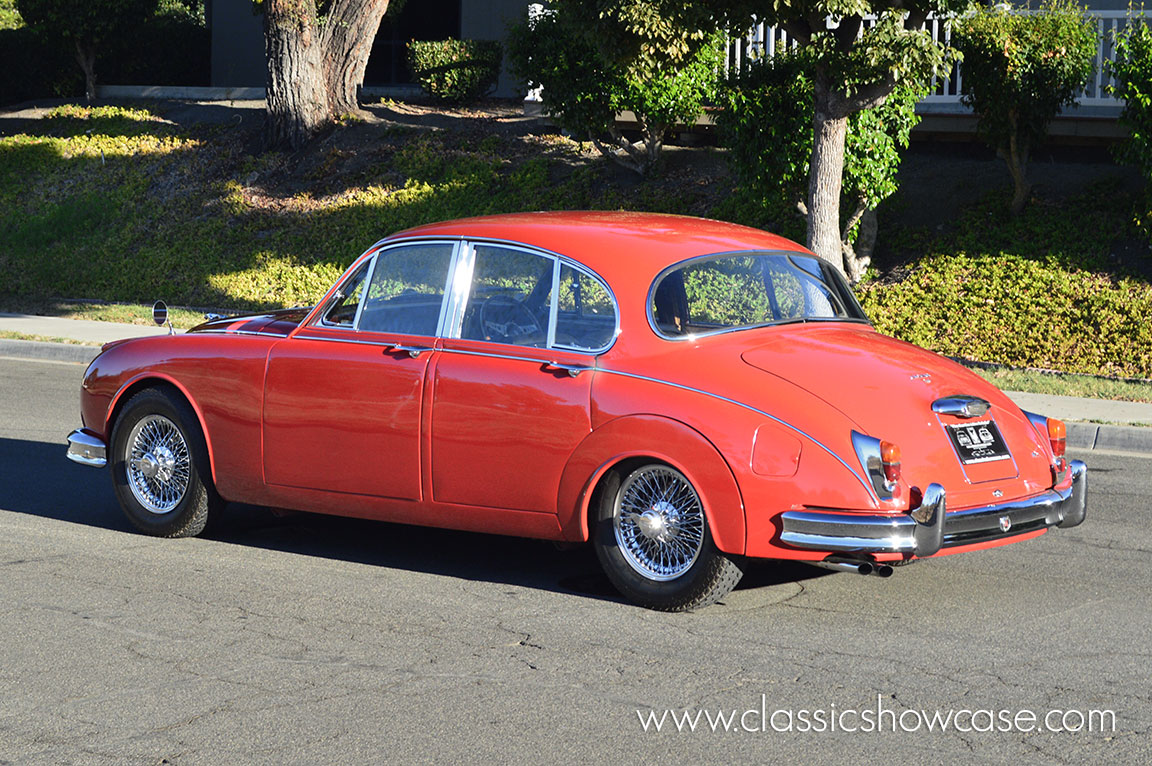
717, 50, 923, 281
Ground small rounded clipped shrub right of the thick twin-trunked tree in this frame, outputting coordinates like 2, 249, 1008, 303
408, 39, 503, 104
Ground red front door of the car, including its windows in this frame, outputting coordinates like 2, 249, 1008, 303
263, 242, 458, 500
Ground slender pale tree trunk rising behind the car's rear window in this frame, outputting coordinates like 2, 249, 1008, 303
808, 71, 848, 273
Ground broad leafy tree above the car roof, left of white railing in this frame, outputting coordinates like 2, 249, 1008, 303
509, 0, 723, 174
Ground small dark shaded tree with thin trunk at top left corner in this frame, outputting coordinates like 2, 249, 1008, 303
16, 0, 159, 101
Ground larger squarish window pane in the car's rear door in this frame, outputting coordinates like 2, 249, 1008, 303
460, 245, 555, 348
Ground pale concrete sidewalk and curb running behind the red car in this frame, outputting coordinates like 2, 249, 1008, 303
0, 313, 1152, 457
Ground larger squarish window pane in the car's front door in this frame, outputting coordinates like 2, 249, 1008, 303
357, 243, 453, 335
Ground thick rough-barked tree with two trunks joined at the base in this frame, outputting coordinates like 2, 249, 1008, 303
260, 0, 403, 149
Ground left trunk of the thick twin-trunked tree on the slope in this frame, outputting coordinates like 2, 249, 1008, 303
264, 0, 333, 150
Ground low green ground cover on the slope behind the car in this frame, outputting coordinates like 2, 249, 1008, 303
0, 103, 1152, 378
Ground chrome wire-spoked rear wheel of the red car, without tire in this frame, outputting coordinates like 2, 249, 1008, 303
613, 465, 704, 582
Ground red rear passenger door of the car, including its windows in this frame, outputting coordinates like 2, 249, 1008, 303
431, 243, 617, 513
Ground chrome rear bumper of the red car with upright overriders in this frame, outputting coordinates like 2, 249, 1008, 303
780, 460, 1087, 556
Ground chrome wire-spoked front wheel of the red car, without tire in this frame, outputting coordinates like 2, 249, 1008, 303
124, 415, 192, 515
